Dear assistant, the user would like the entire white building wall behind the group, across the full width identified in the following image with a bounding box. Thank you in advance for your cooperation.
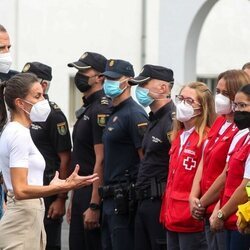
[0,0,250,116]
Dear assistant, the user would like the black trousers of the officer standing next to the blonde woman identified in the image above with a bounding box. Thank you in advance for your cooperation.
[135,199,167,250]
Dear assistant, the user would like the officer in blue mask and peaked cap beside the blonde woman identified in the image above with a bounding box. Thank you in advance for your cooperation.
[129,64,175,250]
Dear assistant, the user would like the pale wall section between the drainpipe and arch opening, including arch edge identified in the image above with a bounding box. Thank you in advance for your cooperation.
[159,0,217,95]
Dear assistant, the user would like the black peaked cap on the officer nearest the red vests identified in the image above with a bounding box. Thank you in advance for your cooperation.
[128,64,174,85]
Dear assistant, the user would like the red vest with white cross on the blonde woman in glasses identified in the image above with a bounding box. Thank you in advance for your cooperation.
[160,131,207,232]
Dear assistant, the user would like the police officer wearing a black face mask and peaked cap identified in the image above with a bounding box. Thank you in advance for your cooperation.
[68,52,111,250]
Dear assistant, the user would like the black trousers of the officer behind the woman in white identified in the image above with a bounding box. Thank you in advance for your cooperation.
[44,196,63,250]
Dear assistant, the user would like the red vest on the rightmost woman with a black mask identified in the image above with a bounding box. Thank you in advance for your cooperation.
[221,135,250,230]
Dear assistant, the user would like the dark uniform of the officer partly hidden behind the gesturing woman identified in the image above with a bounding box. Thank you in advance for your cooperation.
[30,95,71,249]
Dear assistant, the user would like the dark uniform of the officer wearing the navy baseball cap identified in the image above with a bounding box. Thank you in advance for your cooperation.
[101,97,148,250]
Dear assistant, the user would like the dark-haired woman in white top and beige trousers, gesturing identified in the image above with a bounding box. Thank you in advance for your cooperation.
[0,74,98,250]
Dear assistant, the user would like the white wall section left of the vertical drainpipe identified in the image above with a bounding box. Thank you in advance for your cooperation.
[0,0,141,115]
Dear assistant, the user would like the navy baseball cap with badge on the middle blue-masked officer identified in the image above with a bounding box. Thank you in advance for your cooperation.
[102,59,135,79]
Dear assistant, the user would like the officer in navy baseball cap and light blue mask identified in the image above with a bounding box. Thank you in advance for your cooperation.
[100,59,148,250]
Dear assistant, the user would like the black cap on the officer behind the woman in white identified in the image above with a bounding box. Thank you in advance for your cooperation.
[22,62,52,81]
